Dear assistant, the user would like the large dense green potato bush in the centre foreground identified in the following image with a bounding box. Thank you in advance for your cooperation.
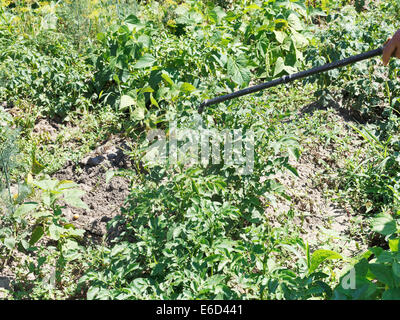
[80,165,337,299]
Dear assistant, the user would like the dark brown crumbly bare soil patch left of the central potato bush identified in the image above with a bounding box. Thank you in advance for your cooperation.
[53,136,130,239]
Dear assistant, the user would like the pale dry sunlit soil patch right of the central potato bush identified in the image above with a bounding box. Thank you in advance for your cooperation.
[266,104,368,257]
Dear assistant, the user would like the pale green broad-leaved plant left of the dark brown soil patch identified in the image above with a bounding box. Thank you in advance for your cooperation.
[0,176,87,299]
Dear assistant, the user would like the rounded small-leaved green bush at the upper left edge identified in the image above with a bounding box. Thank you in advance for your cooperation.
[0,7,91,116]
